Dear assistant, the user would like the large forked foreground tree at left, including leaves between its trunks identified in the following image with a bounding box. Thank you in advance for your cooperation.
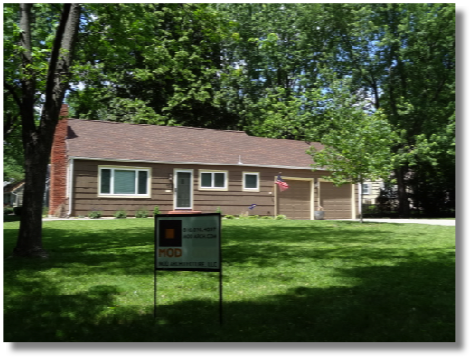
[3,4,80,257]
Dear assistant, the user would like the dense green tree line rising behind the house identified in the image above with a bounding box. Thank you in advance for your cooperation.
[3,3,456,256]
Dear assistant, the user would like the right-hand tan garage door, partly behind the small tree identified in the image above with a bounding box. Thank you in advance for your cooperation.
[319,182,352,219]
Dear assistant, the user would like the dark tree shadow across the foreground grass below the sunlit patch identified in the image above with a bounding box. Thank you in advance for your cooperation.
[4,255,455,342]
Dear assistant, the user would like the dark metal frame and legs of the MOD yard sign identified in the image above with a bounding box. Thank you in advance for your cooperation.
[154,213,223,324]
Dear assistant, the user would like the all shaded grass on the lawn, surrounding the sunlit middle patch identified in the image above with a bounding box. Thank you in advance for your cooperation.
[4,223,455,342]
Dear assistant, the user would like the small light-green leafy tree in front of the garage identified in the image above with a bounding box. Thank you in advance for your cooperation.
[308,78,396,222]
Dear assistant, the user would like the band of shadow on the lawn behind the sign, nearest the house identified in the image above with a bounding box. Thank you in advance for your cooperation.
[3,221,400,275]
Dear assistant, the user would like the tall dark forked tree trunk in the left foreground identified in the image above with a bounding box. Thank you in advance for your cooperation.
[13,4,80,257]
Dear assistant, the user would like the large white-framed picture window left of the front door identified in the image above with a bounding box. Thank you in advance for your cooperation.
[98,166,151,197]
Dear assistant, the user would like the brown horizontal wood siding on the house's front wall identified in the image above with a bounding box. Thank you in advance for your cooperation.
[72,160,352,218]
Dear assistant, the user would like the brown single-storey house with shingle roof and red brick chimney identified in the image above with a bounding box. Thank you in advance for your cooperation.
[49,106,358,219]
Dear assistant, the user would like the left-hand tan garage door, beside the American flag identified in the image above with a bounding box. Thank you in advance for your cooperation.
[277,177,311,220]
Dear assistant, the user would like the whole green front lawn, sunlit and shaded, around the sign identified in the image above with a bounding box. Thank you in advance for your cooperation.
[3,218,455,342]
